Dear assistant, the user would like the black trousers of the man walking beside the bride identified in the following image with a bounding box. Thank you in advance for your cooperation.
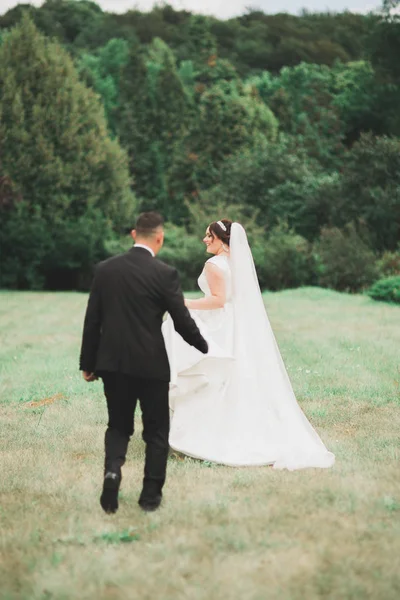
[101,372,169,496]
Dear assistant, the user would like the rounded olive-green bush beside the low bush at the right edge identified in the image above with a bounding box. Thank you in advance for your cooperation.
[314,224,378,292]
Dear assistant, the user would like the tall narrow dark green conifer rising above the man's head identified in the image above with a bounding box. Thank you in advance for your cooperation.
[118,38,190,218]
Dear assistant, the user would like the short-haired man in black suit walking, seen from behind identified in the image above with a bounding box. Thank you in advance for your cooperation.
[80,212,208,513]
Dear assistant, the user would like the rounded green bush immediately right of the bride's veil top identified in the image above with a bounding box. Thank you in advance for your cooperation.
[253,223,314,290]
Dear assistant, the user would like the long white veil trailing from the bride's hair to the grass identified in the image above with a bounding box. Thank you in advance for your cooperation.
[230,223,335,470]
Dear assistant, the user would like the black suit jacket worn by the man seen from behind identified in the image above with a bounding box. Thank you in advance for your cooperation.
[80,247,208,381]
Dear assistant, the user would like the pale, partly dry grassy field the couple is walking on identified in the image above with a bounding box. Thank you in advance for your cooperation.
[0,289,400,600]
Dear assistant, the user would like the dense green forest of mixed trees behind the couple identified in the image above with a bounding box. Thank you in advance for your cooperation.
[0,0,400,291]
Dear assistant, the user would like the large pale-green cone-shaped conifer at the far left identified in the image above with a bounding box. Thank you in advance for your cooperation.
[0,17,135,285]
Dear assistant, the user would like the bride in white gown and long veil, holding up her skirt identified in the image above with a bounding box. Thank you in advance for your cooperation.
[163,219,335,470]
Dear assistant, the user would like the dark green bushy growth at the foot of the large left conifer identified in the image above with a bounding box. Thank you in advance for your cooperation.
[0,202,113,290]
